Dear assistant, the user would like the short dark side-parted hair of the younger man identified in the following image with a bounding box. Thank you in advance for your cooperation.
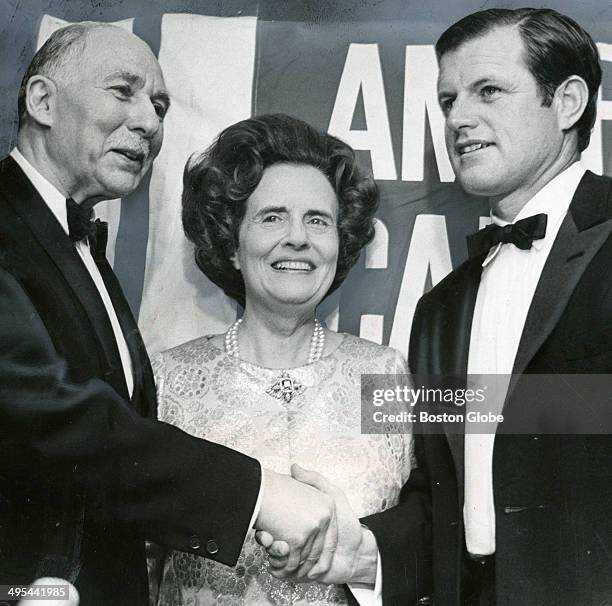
[436,8,601,151]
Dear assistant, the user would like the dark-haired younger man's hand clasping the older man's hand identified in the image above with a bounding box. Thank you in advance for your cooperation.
[257,465,378,585]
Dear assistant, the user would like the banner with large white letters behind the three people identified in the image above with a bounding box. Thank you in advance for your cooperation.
[0,0,612,360]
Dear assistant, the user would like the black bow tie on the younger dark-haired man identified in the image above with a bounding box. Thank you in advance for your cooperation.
[467,213,548,257]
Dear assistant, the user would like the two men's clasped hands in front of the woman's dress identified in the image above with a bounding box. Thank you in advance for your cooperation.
[254,465,378,585]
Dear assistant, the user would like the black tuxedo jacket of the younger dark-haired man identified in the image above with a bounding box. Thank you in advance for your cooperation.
[400,173,612,606]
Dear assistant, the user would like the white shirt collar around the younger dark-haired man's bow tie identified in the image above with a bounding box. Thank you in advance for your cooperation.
[482,161,586,267]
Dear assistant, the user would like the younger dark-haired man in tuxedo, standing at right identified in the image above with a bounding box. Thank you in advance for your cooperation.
[408,9,612,606]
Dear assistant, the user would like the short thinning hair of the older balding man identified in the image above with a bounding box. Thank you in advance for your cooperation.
[17,21,110,128]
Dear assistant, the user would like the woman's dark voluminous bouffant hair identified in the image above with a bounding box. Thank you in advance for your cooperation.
[183,114,378,306]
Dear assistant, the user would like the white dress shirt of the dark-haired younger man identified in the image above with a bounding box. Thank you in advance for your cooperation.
[463,162,585,555]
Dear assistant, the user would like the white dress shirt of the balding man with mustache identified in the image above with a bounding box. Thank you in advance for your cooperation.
[11,147,134,397]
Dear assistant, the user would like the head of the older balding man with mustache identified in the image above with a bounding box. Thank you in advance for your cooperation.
[18,22,169,203]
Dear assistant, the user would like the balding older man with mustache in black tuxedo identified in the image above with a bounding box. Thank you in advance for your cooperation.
[0,23,335,606]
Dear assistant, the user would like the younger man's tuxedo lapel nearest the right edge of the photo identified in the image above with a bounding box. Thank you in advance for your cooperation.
[506,172,612,384]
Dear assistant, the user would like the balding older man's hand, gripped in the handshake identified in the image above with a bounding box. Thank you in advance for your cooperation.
[254,469,338,576]
